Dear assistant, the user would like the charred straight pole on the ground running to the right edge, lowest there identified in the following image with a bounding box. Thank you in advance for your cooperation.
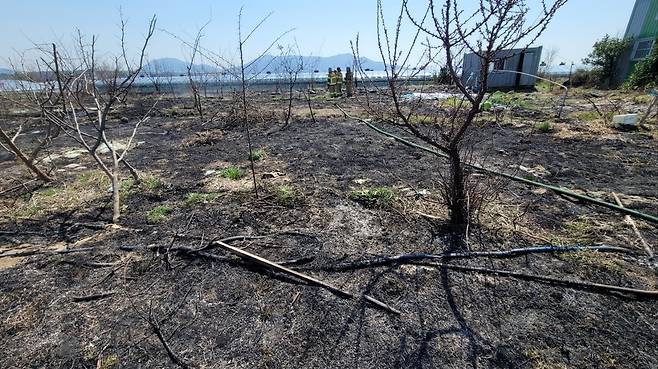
[423,262,658,299]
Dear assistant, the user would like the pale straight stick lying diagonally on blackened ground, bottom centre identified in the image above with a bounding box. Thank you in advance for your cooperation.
[213,241,401,315]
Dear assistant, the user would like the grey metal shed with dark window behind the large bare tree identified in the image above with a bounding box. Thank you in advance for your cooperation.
[461,46,542,91]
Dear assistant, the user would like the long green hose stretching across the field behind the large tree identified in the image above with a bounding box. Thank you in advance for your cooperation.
[336,104,658,225]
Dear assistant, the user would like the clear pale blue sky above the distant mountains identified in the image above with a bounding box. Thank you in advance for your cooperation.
[0,0,635,65]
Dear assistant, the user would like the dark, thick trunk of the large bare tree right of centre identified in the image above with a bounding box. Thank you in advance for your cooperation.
[448,147,469,240]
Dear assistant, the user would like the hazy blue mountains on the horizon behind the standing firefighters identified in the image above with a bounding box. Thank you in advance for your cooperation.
[143,54,384,76]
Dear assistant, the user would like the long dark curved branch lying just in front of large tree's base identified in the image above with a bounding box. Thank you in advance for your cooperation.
[323,246,633,271]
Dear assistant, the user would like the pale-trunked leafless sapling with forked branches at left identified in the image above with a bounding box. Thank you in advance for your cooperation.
[34,16,156,223]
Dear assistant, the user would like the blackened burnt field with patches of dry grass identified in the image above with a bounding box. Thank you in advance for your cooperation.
[0,92,658,368]
